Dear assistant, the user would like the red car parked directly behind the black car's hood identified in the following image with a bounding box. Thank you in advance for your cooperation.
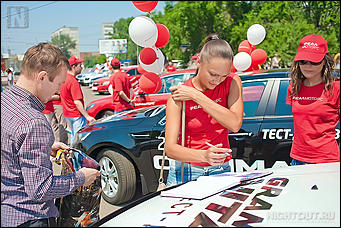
[86,69,195,119]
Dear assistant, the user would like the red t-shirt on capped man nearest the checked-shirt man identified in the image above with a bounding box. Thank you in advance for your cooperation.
[60,74,84,118]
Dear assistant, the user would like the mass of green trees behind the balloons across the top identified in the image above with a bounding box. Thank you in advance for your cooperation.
[107,1,340,66]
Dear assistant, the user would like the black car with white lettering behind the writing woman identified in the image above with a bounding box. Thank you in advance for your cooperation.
[74,72,340,204]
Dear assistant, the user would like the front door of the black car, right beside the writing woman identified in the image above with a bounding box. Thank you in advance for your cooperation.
[229,78,274,172]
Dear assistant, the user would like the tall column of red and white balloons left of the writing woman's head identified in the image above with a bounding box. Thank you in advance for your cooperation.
[129,1,170,94]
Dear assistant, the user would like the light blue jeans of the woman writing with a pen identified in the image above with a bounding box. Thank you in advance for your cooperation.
[166,160,231,187]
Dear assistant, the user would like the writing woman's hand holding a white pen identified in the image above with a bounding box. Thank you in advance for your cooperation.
[206,144,232,166]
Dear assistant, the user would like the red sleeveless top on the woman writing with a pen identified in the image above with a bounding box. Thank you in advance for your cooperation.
[178,75,234,166]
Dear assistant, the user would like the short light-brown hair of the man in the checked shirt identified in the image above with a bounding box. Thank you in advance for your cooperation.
[21,43,70,82]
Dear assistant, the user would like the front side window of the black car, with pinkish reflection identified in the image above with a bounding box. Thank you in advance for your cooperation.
[243,81,267,117]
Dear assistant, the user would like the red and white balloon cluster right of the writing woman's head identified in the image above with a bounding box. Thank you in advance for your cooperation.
[231,24,267,72]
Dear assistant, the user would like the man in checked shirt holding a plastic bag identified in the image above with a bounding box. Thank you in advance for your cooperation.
[1,43,100,227]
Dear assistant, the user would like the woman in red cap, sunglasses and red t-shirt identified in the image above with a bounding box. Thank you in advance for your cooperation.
[287,35,340,165]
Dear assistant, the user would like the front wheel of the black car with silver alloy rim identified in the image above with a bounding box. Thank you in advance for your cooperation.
[97,149,136,204]
